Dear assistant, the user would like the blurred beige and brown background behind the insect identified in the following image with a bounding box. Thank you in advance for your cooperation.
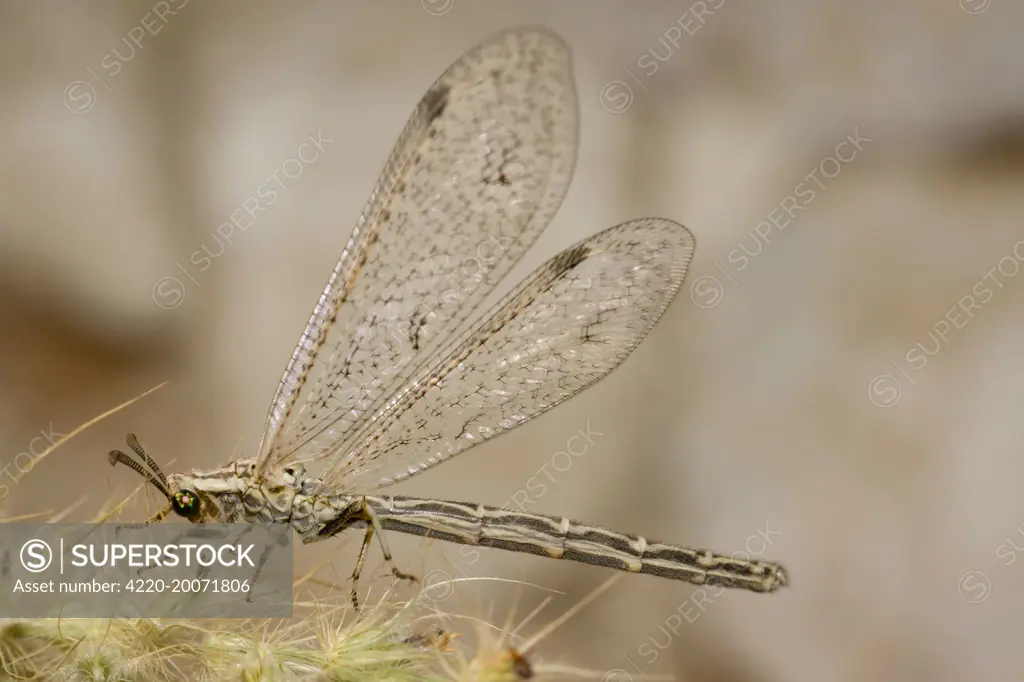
[0,0,1024,682]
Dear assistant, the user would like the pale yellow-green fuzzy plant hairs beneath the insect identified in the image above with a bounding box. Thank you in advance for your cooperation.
[0,384,613,682]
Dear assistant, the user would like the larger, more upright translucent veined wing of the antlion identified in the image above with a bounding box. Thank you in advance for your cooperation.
[258,29,578,472]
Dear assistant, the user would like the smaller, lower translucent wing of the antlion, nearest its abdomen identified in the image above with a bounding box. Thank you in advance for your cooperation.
[322,218,694,491]
